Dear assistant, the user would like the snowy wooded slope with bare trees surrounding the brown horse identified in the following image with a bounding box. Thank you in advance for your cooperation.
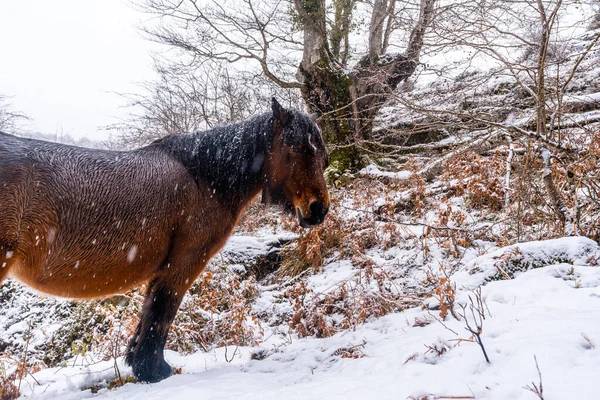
[0,0,600,400]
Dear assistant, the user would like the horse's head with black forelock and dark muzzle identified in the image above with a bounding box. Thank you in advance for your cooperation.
[263,98,329,228]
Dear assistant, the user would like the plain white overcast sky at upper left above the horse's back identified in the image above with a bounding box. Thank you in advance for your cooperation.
[0,0,156,139]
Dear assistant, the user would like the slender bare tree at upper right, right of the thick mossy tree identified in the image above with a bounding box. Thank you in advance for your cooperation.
[433,0,600,145]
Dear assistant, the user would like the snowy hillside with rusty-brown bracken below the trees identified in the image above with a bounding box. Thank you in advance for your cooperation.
[0,25,600,400]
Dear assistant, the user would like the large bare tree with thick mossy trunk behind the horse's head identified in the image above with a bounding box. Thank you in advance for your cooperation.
[140,0,435,170]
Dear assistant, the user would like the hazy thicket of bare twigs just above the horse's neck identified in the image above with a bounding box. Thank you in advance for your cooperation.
[107,60,300,147]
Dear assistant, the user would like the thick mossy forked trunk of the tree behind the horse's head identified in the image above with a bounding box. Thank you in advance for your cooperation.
[294,0,426,172]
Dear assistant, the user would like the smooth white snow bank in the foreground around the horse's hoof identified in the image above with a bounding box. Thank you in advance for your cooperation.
[11,237,600,400]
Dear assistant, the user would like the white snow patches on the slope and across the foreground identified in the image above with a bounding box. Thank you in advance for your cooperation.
[0,7,600,400]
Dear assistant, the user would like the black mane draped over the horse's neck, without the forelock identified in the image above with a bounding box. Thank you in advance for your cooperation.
[159,115,273,211]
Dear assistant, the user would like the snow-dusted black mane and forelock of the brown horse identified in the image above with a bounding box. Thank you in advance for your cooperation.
[152,104,327,211]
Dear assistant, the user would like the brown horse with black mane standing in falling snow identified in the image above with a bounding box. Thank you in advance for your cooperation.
[0,99,329,382]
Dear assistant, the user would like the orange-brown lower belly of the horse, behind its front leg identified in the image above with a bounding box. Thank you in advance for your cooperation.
[9,230,169,299]
